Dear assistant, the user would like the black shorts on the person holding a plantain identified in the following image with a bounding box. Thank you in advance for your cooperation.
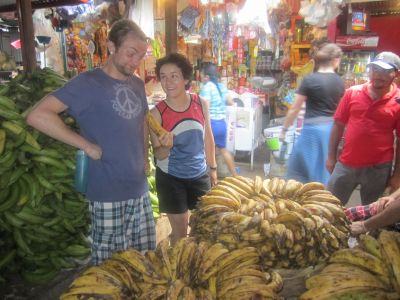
[156,168,211,214]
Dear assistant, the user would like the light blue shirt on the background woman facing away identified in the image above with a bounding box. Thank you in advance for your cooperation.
[200,81,228,120]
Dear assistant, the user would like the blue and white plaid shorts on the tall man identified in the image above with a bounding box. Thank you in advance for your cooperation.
[89,192,156,265]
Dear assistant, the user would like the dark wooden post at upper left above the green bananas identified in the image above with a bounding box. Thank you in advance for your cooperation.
[16,0,37,73]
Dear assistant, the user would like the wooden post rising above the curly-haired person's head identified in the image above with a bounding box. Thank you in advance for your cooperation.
[165,0,178,54]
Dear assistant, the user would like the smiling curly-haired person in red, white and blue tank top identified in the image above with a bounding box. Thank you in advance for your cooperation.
[150,53,217,245]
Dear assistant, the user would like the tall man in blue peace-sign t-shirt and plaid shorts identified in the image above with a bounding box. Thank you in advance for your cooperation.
[27,20,155,265]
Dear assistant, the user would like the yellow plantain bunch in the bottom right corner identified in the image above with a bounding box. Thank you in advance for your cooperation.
[299,231,400,300]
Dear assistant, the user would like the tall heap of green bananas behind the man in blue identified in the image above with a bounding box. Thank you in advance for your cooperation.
[0,70,90,283]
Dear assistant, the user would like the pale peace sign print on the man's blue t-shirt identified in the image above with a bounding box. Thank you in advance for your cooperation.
[111,84,142,119]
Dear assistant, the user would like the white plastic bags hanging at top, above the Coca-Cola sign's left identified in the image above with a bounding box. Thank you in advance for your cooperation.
[299,0,344,27]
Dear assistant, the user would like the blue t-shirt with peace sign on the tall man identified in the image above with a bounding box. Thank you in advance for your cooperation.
[53,69,148,202]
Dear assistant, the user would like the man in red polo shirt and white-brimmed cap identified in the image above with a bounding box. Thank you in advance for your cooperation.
[326,52,400,205]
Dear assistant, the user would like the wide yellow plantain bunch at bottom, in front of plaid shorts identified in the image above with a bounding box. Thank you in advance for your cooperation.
[60,238,283,300]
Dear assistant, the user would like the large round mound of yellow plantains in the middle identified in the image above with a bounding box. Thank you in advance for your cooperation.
[190,176,349,268]
